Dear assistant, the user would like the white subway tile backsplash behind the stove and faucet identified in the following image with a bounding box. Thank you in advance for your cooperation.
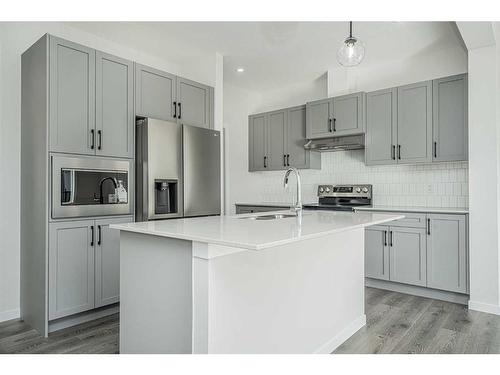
[261,150,469,207]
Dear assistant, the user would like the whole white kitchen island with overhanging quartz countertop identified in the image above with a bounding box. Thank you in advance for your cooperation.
[112,211,404,353]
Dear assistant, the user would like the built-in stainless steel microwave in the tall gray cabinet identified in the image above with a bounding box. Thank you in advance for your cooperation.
[51,155,133,219]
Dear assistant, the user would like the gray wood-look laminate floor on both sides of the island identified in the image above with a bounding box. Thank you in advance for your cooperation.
[0,288,500,354]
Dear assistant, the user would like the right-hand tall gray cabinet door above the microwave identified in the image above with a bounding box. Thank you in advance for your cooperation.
[96,51,134,158]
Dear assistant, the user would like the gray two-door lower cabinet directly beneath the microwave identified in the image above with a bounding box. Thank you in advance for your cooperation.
[49,216,133,320]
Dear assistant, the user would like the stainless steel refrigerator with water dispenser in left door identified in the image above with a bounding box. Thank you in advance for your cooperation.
[136,118,221,221]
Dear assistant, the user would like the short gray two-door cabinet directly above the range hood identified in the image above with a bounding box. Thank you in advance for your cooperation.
[306,92,365,139]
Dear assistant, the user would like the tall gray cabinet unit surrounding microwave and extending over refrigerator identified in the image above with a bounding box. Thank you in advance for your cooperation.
[21,35,213,335]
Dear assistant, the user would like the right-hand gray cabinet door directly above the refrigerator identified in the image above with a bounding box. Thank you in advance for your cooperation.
[177,77,211,128]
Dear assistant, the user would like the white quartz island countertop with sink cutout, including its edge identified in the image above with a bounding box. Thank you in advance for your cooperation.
[111,211,404,250]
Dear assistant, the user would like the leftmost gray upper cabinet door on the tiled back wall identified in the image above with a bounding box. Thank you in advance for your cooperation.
[248,114,268,171]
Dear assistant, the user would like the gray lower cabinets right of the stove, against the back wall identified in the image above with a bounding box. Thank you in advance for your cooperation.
[365,212,468,294]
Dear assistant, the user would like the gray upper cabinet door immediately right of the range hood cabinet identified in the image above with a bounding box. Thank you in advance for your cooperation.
[365,88,398,165]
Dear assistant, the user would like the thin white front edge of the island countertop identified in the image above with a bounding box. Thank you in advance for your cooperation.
[110,214,404,250]
